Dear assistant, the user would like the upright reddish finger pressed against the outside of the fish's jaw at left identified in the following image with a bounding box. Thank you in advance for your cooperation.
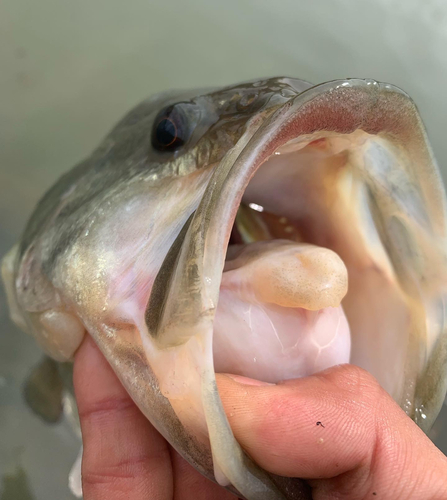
[73,335,173,500]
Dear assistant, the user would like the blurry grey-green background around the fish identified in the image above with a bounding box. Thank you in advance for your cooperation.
[0,0,447,500]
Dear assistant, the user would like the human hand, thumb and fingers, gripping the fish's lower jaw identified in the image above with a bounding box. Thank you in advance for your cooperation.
[74,336,447,500]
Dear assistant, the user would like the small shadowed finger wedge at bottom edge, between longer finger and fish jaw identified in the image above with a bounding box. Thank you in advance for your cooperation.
[171,448,237,500]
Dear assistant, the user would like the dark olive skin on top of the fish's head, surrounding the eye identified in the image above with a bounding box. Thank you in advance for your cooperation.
[20,78,308,274]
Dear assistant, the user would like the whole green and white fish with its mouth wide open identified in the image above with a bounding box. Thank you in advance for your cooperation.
[2,77,447,500]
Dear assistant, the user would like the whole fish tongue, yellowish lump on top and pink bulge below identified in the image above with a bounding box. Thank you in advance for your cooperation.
[213,240,351,382]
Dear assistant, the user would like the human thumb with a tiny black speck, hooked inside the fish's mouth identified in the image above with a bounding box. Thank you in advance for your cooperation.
[217,365,447,500]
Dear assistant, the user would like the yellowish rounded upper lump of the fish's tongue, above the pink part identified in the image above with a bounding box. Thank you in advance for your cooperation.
[221,240,348,311]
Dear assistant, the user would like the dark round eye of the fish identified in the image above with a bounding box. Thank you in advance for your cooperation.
[152,104,191,151]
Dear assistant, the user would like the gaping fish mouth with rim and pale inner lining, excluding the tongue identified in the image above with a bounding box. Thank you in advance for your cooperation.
[143,80,447,498]
